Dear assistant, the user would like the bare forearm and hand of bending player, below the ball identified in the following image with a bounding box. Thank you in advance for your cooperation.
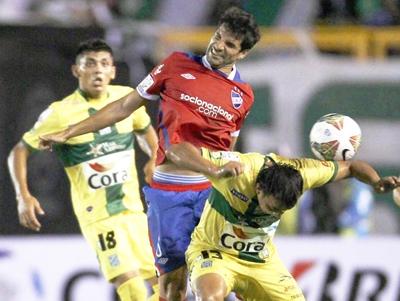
[334,160,400,193]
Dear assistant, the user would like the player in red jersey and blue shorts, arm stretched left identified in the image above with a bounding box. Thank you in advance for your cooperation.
[41,8,260,301]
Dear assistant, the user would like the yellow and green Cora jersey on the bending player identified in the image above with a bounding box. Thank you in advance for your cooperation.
[189,149,337,262]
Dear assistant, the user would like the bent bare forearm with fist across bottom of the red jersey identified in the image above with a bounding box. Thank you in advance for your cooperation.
[166,142,243,178]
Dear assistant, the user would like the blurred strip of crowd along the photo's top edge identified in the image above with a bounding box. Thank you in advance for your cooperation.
[0,0,400,27]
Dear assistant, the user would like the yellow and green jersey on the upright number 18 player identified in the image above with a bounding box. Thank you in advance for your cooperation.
[23,85,150,225]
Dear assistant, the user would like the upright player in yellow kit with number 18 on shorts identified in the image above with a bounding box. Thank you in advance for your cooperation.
[9,39,158,301]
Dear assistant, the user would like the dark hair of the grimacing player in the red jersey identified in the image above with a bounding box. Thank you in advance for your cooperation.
[218,6,260,50]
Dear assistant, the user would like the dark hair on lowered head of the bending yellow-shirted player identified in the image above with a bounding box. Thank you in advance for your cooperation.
[256,164,303,209]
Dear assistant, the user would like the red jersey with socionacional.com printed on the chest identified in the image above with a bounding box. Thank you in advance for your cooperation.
[137,52,254,164]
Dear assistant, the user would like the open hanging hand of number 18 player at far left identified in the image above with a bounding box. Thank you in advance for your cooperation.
[18,196,44,231]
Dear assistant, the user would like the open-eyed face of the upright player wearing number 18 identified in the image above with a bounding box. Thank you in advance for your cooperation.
[72,51,115,98]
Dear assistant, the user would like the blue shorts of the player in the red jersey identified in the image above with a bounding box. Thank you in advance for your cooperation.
[143,186,211,275]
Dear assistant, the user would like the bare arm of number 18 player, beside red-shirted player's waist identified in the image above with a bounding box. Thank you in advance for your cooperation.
[135,125,158,184]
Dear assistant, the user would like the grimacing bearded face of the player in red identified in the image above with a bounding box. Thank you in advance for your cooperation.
[206,25,248,73]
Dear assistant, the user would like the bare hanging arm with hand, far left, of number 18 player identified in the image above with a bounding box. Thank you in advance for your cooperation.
[8,142,44,231]
